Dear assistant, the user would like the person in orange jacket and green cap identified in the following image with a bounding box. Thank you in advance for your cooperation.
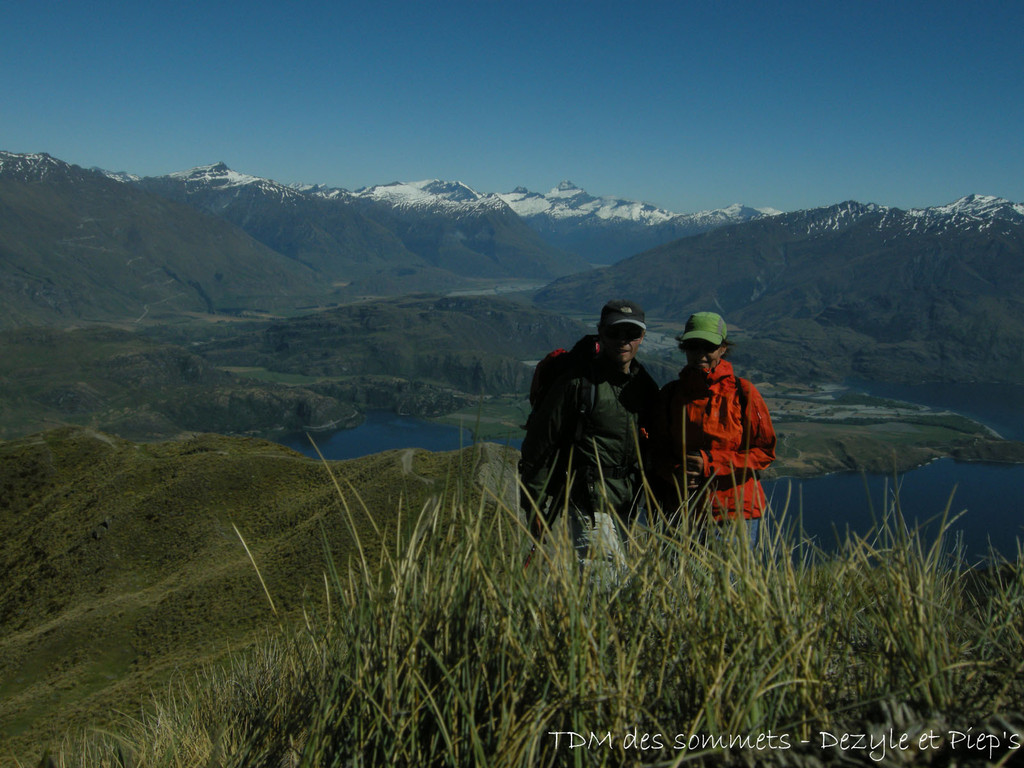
[653,312,775,546]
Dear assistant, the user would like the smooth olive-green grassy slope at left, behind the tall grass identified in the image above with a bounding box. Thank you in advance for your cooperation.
[0,429,512,759]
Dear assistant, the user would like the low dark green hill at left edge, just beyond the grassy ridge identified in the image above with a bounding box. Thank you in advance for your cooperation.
[0,327,361,440]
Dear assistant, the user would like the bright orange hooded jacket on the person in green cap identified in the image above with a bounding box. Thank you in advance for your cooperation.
[653,360,775,520]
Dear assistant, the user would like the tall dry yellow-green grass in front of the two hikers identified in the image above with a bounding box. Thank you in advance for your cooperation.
[51,462,1024,768]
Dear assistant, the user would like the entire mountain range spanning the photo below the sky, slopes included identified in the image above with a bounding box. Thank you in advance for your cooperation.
[6,153,1024,381]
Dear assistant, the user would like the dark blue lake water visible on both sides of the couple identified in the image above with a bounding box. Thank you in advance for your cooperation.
[284,382,1024,562]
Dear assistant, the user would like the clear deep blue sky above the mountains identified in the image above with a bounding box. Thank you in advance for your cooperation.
[0,0,1024,213]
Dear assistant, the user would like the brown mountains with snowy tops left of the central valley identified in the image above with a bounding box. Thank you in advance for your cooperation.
[0,152,588,328]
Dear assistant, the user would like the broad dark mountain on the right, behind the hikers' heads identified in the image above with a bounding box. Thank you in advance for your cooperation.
[537,196,1024,381]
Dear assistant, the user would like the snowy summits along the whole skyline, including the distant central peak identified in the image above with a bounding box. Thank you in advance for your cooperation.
[0,152,1024,263]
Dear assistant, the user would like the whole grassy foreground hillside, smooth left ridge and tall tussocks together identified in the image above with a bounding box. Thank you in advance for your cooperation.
[0,431,1024,768]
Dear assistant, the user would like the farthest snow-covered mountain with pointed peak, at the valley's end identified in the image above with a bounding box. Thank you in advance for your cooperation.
[498,181,779,264]
